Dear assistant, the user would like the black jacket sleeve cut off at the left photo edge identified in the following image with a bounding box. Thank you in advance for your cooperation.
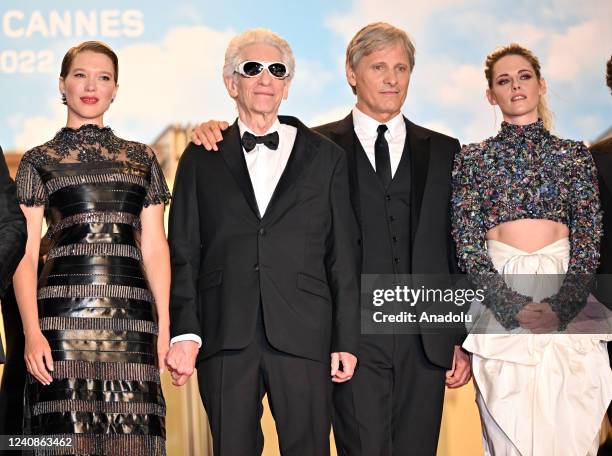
[0,148,27,362]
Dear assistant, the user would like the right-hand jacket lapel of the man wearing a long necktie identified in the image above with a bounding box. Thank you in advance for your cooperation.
[404,117,429,242]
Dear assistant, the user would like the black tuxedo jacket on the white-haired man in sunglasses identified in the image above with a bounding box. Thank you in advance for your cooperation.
[168,117,360,362]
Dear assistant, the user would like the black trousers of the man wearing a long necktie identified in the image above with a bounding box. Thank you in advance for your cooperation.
[333,334,446,456]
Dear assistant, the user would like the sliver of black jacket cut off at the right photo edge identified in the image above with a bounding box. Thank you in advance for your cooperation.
[591,138,612,306]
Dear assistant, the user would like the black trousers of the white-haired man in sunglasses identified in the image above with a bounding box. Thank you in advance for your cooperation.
[198,310,332,456]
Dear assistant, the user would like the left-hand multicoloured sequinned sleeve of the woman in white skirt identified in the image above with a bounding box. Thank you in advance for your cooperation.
[452,144,531,330]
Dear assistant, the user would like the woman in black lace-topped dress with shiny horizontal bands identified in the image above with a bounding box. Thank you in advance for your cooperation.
[14,41,170,456]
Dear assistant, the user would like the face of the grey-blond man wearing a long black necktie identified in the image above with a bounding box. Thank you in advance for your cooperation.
[346,44,410,122]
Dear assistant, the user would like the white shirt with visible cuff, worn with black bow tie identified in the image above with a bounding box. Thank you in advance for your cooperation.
[170,118,298,347]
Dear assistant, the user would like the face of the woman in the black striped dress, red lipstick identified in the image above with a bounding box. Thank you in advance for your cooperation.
[59,51,118,125]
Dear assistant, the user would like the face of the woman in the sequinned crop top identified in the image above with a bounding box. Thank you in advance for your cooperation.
[487,55,546,124]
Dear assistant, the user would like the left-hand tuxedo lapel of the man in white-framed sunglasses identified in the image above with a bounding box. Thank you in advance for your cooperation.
[219,121,261,218]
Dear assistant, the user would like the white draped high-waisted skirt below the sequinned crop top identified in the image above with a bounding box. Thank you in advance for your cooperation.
[463,238,612,456]
